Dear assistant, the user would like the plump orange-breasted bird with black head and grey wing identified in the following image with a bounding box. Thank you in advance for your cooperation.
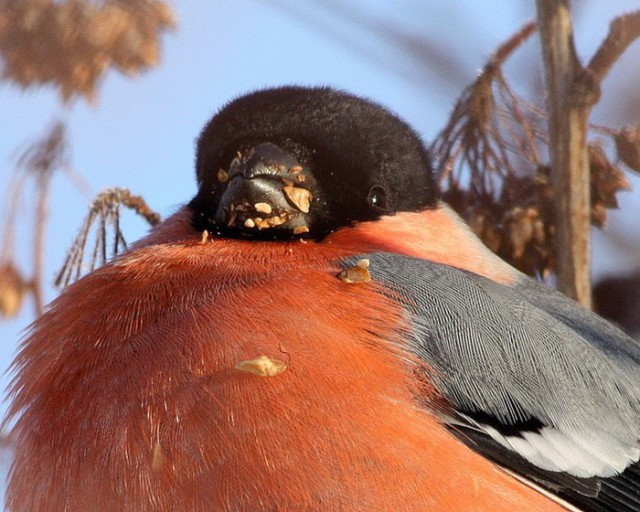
[5,86,640,512]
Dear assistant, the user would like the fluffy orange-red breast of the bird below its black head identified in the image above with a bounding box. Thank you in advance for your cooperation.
[9,222,560,512]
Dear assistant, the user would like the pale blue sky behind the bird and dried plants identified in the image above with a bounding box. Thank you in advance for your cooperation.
[0,0,640,496]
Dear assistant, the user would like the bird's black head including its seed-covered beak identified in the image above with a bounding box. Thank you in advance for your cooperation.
[190,87,437,239]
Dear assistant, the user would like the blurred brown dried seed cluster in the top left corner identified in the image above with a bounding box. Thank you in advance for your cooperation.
[0,0,175,101]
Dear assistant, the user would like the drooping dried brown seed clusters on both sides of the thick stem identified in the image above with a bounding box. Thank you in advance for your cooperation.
[432,18,640,277]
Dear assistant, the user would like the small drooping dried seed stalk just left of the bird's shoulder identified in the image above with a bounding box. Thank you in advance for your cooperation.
[55,188,160,288]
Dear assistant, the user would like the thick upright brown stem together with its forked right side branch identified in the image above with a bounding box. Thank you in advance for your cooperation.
[537,4,640,306]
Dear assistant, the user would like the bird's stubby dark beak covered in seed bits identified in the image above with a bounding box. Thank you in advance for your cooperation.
[215,143,315,238]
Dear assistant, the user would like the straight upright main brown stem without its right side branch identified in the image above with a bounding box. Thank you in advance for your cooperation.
[536,0,593,307]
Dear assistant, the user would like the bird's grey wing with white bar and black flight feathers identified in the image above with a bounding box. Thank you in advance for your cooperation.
[344,253,640,512]
